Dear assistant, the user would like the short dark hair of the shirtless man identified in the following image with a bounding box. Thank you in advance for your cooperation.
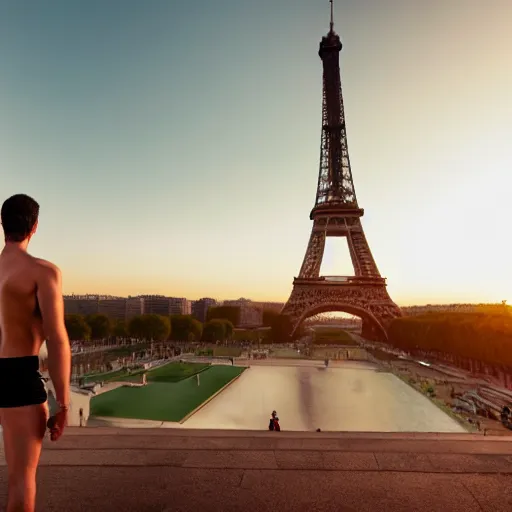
[1,194,39,242]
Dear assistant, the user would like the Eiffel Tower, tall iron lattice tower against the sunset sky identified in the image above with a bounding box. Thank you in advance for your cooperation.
[282,0,401,341]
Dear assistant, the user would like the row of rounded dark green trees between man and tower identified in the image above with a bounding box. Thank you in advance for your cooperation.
[65,314,233,342]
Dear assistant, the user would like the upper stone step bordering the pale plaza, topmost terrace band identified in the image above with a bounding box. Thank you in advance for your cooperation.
[40,429,512,455]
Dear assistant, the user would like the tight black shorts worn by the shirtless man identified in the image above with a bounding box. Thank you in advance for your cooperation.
[0,356,48,409]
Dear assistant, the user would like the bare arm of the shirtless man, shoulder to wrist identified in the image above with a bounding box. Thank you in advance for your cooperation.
[37,264,71,406]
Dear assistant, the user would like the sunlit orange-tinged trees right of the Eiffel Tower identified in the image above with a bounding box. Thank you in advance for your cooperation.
[388,313,512,367]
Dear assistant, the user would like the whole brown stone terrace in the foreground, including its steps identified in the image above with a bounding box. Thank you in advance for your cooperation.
[0,428,512,512]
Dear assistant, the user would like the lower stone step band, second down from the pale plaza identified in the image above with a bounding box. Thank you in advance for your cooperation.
[9,448,512,475]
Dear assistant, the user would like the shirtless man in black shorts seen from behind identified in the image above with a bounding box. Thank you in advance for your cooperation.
[0,194,71,512]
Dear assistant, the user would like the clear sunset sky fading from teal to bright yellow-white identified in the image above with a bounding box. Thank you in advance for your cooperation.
[0,0,512,305]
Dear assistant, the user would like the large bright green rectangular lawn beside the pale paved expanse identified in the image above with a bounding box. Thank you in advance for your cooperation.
[91,366,245,421]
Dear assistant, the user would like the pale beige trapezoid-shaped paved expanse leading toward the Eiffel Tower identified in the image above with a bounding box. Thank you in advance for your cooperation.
[184,361,466,432]
